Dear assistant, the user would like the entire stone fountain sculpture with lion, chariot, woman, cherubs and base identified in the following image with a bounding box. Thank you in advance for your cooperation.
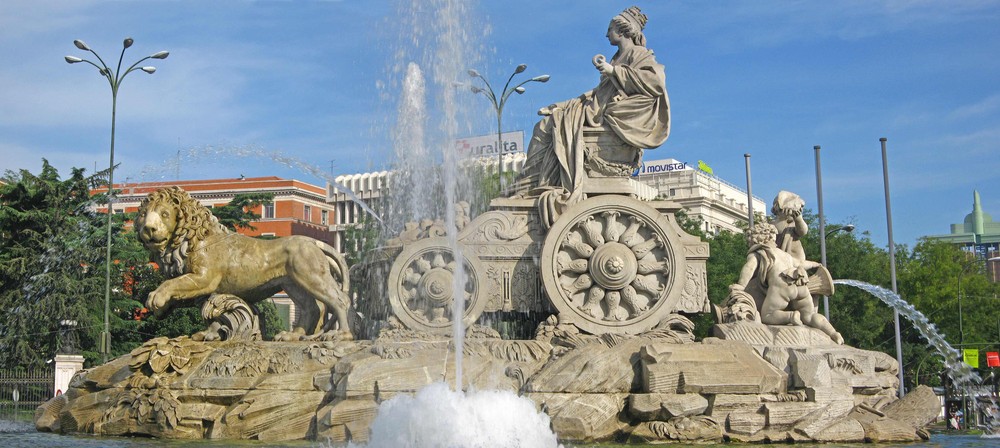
[35,7,938,443]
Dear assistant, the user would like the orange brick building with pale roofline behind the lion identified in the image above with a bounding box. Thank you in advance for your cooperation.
[99,176,335,244]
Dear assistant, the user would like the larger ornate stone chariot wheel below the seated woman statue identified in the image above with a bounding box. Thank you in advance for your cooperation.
[541,195,687,334]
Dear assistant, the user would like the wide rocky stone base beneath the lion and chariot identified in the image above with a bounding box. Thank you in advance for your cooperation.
[35,323,938,443]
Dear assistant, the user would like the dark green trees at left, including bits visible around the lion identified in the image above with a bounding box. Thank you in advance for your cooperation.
[0,164,282,367]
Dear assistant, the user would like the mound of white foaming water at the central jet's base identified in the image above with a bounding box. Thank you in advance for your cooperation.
[358,382,560,448]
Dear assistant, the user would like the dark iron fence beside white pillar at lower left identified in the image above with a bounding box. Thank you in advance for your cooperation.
[0,369,55,421]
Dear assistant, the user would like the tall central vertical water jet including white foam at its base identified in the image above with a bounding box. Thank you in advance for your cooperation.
[356,0,558,448]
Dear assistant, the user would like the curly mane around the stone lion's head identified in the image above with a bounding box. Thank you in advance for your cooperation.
[136,186,231,278]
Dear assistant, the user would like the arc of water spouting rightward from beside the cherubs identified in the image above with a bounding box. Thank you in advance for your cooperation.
[833,280,996,432]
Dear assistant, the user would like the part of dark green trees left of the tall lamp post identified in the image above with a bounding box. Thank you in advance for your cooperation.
[0,159,107,367]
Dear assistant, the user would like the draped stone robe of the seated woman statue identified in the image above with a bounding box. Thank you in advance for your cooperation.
[515,45,670,224]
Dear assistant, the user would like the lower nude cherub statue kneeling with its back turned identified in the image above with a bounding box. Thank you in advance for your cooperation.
[729,222,844,344]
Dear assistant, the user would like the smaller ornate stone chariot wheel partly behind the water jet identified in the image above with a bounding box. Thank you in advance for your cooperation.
[389,238,486,334]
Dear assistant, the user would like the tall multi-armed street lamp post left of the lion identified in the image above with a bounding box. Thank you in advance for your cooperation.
[66,37,170,362]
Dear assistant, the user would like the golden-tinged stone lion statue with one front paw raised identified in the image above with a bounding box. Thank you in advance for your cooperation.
[135,187,353,340]
